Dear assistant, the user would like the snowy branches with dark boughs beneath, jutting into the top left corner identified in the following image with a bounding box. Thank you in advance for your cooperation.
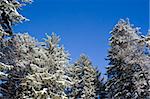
[0,0,31,39]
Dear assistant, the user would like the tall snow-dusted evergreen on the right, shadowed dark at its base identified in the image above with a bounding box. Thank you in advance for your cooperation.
[106,20,150,99]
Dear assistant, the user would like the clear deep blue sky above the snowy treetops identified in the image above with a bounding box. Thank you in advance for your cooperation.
[14,0,149,74]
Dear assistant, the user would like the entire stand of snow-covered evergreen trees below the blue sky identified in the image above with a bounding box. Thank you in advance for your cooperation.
[0,0,150,99]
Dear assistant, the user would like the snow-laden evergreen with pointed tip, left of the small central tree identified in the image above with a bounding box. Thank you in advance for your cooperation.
[16,33,71,99]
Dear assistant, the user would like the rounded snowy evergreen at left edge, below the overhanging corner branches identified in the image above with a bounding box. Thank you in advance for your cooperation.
[0,34,39,98]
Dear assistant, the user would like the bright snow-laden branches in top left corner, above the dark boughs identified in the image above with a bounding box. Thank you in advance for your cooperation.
[0,0,32,23]
